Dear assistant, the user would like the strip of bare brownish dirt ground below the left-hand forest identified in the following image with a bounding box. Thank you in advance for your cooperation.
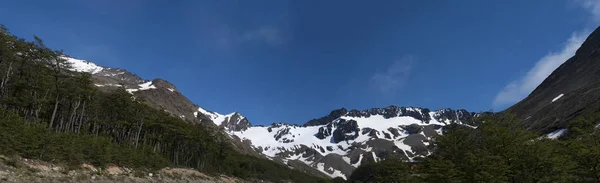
[0,155,266,183]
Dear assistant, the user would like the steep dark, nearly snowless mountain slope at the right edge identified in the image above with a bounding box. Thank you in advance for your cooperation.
[503,28,600,133]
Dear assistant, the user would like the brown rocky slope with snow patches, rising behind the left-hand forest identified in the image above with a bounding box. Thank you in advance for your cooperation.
[63,56,251,130]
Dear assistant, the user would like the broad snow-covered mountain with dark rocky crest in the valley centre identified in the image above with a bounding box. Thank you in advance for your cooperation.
[218,106,477,178]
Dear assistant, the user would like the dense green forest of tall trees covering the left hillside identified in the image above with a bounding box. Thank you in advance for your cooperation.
[0,26,328,182]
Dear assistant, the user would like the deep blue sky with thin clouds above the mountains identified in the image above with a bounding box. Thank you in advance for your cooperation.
[0,0,600,124]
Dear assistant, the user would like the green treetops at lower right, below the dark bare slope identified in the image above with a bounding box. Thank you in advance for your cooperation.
[348,112,600,183]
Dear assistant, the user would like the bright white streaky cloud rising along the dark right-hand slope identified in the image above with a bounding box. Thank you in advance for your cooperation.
[493,0,600,107]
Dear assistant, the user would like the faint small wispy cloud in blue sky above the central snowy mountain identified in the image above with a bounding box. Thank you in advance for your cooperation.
[371,56,414,94]
